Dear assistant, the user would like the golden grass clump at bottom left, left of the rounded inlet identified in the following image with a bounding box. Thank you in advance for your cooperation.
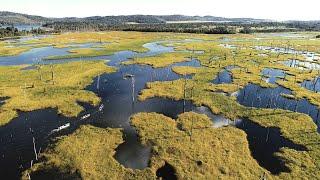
[22,126,155,179]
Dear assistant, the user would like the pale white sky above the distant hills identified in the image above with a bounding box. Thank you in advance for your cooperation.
[0,0,320,21]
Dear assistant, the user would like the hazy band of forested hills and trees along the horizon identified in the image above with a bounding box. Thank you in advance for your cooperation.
[0,11,320,38]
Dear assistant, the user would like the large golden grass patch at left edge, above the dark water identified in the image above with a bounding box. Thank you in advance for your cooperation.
[0,61,115,125]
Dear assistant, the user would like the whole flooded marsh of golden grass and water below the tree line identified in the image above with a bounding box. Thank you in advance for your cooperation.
[0,31,320,179]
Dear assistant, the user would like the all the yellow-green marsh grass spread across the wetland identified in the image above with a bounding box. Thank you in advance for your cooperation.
[0,32,320,179]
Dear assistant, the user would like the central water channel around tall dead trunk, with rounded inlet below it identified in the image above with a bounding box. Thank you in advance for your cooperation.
[88,60,199,169]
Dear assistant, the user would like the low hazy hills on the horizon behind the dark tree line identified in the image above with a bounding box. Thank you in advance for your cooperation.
[0,11,269,25]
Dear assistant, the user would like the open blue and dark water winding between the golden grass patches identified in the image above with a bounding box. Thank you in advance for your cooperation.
[0,39,319,179]
